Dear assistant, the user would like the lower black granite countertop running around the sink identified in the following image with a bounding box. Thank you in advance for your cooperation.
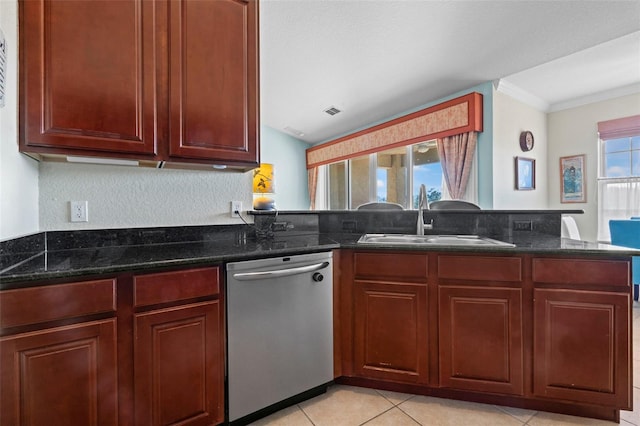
[0,233,640,289]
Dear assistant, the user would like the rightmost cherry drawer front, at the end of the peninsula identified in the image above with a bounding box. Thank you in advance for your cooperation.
[532,258,631,287]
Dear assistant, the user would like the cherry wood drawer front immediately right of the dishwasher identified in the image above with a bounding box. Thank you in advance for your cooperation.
[354,252,427,280]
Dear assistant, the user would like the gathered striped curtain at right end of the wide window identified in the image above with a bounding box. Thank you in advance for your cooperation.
[438,132,477,201]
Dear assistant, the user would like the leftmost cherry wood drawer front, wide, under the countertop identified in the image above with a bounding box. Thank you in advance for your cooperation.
[0,279,116,328]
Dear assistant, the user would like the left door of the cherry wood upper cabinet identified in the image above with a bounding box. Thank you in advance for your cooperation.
[20,0,157,156]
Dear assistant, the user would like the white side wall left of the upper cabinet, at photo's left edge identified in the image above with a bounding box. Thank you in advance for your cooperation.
[0,1,38,240]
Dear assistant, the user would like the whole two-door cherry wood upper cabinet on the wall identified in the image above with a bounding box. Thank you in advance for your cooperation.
[19,0,259,169]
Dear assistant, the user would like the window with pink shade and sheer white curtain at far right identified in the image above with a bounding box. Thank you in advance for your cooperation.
[598,116,640,241]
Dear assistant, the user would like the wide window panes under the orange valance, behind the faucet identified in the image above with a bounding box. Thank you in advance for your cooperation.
[318,140,443,210]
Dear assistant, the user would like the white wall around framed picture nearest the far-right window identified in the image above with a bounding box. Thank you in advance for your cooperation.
[547,94,640,241]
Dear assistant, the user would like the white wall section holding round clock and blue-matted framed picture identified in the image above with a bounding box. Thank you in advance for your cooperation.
[493,91,550,210]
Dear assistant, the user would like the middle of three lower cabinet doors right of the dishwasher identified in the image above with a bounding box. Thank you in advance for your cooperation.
[438,286,523,395]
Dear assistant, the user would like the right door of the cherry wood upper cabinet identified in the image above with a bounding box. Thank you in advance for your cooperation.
[169,0,259,165]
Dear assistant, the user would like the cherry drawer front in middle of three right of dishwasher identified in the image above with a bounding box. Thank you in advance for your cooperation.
[438,255,522,282]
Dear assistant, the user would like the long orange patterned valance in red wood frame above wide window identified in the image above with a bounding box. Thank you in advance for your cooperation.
[307,92,482,169]
